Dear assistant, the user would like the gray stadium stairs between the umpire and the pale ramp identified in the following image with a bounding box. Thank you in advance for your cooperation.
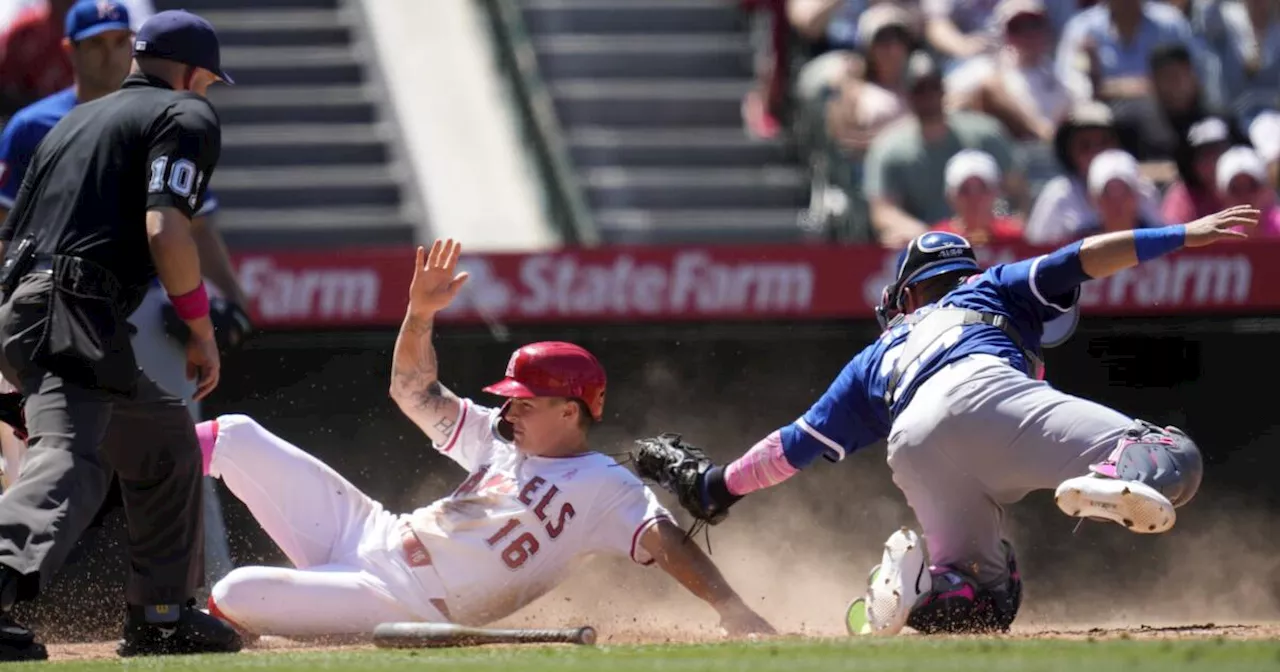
[155,0,416,248]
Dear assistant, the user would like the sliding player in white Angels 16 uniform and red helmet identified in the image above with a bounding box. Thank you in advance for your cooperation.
[197,241,773,636]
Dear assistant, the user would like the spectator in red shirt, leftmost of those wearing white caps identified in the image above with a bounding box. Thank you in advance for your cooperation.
[933,150,1023,244]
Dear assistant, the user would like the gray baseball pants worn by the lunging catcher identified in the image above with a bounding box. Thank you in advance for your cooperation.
[888,355,1133,586]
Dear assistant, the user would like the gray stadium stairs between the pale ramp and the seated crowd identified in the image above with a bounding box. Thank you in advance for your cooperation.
[520,0,809,243]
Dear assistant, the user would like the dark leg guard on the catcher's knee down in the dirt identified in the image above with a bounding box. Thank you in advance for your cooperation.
[906,541,1023,635]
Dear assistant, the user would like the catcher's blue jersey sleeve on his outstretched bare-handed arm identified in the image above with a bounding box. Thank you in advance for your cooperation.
[987,242,1089,321]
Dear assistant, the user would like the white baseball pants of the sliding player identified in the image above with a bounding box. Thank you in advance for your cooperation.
[209,415,445,636]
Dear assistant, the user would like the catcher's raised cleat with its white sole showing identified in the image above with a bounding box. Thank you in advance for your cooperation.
[1053,474,1178,534]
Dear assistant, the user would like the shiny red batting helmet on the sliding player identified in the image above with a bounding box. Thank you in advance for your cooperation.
[484,340,604,421]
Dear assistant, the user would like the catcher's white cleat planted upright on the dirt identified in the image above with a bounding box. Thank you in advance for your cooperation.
[845,527,933,635]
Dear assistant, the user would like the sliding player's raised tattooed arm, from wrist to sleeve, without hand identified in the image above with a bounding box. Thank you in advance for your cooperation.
[390,311,462,445]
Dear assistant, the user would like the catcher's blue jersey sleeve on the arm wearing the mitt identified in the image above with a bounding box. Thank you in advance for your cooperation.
[782,346,890,468]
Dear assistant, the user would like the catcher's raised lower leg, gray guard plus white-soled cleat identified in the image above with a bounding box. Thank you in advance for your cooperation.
[1055,420,1203,534]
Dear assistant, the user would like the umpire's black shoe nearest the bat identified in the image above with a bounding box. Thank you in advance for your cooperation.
[115,600,243,658]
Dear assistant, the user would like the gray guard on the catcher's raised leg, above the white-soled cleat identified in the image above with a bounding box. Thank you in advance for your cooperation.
[1115,420,1204,507]
